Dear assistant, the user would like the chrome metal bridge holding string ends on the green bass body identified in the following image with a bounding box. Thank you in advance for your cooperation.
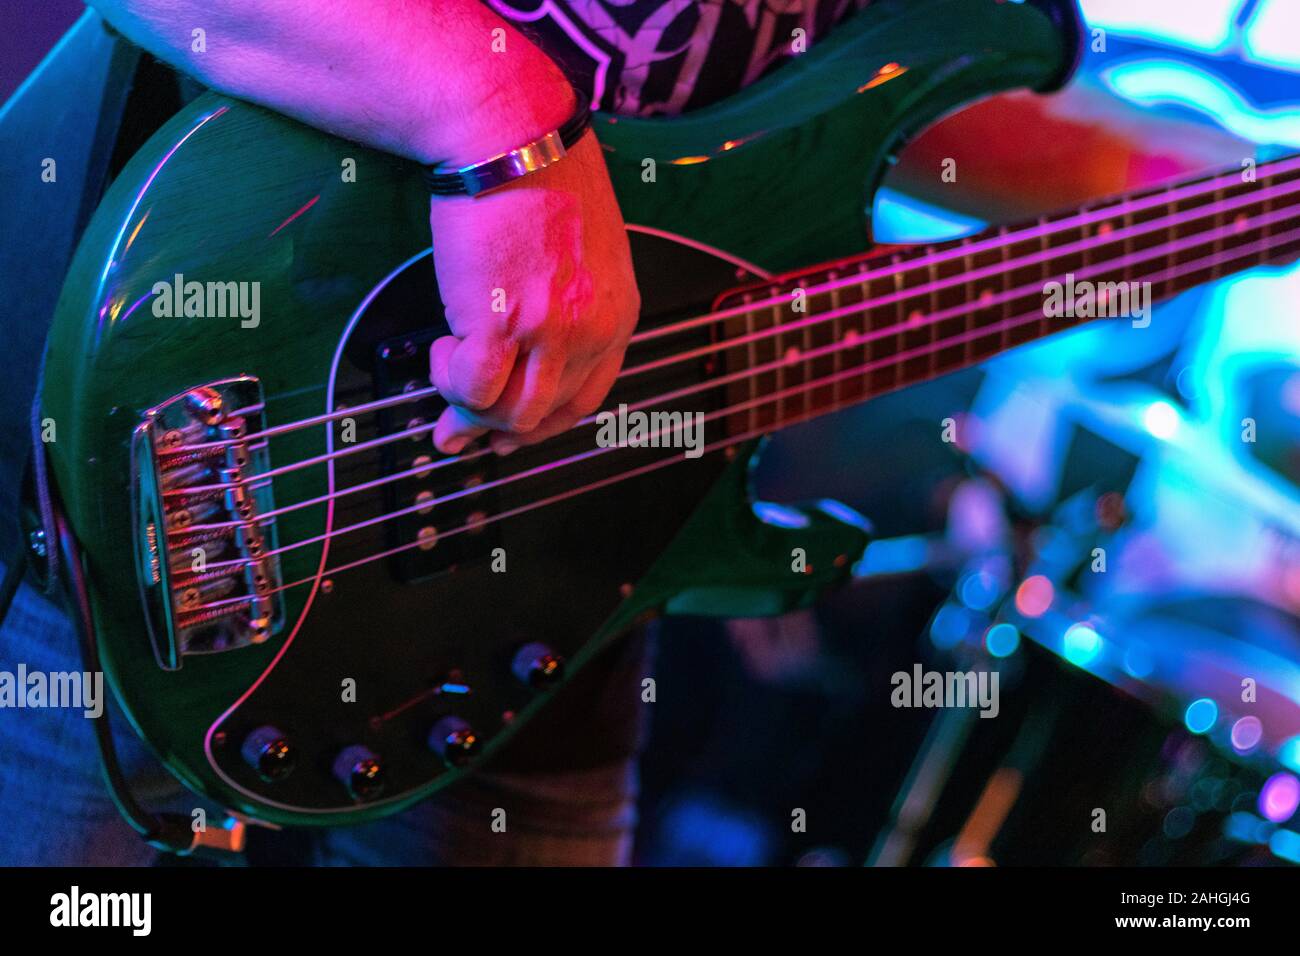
[131,376,283,670]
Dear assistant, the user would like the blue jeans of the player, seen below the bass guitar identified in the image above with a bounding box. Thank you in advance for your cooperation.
[0,567,645,866]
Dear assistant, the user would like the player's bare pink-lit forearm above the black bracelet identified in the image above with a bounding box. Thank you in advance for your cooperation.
[88,0,573,163]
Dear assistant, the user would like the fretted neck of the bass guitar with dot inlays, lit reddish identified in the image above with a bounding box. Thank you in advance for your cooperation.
[714,156,1300,436]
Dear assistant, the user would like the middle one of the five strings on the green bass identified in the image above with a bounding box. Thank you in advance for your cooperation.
[168,201,1290,535]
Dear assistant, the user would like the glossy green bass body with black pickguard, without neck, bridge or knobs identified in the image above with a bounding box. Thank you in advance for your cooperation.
[42,0,1078,825]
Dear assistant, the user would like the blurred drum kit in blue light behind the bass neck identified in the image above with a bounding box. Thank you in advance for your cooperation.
[858,261,1300,865]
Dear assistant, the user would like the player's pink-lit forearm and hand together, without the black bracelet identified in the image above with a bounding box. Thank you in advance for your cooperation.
[88,0,638,453]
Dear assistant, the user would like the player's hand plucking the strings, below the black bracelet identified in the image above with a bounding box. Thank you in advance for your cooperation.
[429,134,640,454]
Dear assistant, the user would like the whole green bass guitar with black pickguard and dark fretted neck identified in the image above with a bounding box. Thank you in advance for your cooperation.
[40,0,1300,825]
